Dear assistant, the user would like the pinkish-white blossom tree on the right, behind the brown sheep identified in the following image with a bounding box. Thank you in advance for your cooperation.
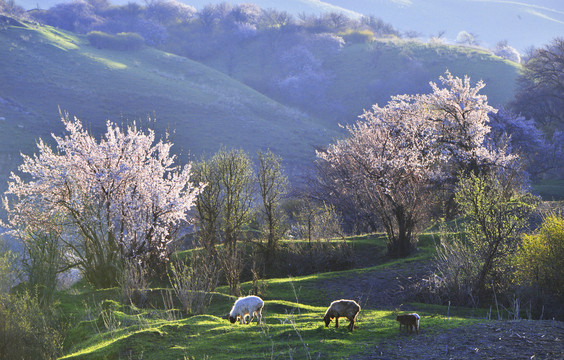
[318,71,514,256]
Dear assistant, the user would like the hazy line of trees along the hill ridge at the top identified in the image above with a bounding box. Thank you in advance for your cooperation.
[22,0,400,46]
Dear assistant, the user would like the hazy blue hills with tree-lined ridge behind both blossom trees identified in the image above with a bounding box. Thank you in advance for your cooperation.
[0,1,556,198]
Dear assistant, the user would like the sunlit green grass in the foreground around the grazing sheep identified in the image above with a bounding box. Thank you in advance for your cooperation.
[59,236,485,359]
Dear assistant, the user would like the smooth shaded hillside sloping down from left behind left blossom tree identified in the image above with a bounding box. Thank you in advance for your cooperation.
[0,19,333,187]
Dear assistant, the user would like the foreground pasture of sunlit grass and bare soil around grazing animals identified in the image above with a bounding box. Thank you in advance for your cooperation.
[53,234,564,360]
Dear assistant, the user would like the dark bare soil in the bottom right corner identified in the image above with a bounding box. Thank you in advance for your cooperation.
[350,320,564,360]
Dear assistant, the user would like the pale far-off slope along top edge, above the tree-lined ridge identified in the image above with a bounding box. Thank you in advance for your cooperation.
[16,0,564,52]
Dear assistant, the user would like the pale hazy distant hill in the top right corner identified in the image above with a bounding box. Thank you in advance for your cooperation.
[325,0,564,52]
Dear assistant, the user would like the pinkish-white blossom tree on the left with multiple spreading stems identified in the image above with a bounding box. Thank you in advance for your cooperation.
[4,114,202,286]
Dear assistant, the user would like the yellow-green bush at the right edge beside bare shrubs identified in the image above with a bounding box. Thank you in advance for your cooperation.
[515,213,564,296]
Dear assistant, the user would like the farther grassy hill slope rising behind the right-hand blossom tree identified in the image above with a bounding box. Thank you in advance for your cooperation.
[205,38,520,124]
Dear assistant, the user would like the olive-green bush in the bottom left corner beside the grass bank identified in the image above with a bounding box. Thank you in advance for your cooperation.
[0,292,63,359]
